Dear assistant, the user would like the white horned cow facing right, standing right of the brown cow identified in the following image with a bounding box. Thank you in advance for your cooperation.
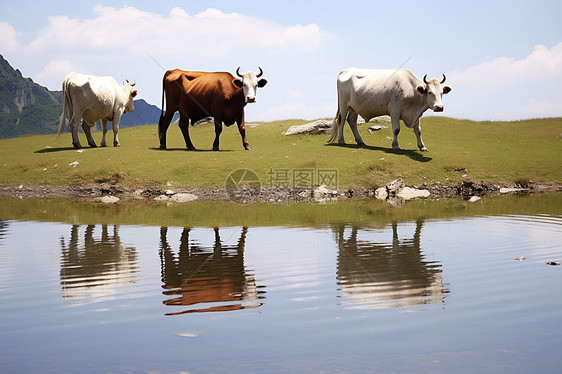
[329,68,451,152]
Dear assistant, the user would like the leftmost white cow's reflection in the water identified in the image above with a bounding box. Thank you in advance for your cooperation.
[60,225,137,298]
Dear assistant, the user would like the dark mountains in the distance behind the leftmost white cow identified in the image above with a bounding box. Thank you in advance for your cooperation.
[0,55,167,139]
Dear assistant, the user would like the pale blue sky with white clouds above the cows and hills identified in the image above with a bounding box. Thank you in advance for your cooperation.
[0,0,562,121]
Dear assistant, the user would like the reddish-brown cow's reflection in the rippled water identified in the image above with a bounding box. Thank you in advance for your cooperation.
[160,227,265,315]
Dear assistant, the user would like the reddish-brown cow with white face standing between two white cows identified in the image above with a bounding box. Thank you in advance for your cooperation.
[158,68,267,151]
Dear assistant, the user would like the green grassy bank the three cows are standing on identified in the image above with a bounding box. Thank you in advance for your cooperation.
[0,117,562,188]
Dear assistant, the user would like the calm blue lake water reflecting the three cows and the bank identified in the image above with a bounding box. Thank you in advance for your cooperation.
[0,194,562,373]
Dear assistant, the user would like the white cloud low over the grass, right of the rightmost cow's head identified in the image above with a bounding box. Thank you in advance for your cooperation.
[446,42,562,120]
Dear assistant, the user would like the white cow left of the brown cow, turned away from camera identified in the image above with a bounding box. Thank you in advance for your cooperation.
[58,73,137,148]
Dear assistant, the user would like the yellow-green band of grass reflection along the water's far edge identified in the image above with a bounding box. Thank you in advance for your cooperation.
[0,193,562,227]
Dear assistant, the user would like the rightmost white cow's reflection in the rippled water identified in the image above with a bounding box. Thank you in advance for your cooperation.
[334,220,448,308]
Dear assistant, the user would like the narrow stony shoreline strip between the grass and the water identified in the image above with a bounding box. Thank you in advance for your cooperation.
[0,180,562,204]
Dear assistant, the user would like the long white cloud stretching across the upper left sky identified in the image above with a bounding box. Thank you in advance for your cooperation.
[25,5,327,59]
